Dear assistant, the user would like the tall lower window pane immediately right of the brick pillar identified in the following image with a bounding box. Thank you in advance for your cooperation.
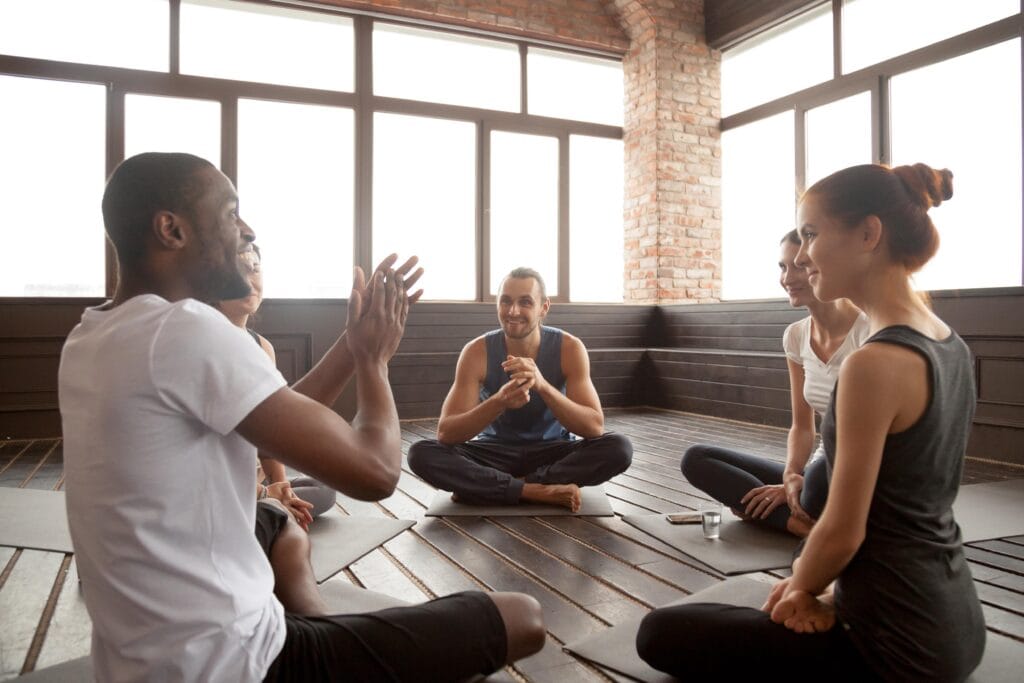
[722,112,797,299]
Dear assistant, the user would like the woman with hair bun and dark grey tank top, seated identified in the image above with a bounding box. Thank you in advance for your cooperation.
[637,164,985,681]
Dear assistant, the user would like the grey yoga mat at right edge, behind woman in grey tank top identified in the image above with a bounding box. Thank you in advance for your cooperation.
[953,479,1024,543]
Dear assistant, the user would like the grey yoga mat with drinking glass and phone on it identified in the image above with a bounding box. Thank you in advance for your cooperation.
[623,508,800,574]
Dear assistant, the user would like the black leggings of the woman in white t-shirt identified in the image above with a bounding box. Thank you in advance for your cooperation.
[681,444,828,531]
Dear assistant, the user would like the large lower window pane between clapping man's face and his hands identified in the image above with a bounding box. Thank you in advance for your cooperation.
[239,99,355,298]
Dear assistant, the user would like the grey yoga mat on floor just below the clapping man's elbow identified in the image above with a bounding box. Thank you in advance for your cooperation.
[309,508,416,584]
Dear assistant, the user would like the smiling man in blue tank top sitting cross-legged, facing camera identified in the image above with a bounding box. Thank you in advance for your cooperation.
[409,268,633,512]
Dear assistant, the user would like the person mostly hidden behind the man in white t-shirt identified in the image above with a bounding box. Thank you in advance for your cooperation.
[217,243,337,528]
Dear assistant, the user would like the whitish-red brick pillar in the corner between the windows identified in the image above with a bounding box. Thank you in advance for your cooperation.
[612,0,722,303]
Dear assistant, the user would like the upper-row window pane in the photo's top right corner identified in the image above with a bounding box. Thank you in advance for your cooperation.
[843,0,1021,73]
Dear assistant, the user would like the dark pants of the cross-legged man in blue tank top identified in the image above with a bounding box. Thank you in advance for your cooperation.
[409,432,633,505]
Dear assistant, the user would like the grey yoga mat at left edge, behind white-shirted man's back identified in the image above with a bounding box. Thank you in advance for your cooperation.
[0,487,74,553]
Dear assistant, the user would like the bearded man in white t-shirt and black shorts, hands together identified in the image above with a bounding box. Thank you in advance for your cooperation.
[59,153,545,681]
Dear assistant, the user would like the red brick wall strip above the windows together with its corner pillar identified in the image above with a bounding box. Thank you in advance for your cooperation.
[311,0,722,303]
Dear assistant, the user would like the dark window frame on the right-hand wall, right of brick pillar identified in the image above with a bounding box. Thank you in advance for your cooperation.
[721,0,1024,301]
